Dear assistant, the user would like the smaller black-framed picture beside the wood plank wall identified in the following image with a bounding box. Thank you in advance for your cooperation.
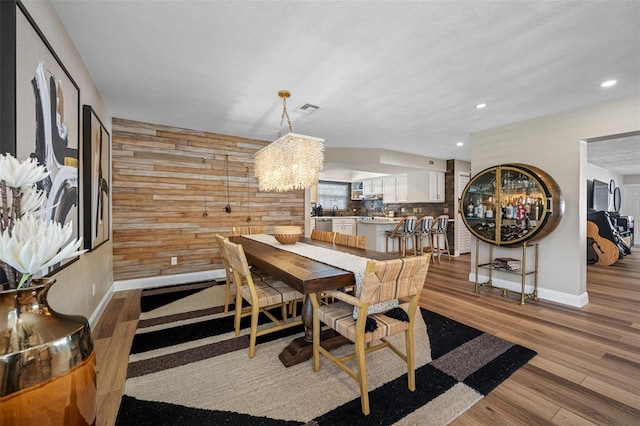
[82,105,111,251]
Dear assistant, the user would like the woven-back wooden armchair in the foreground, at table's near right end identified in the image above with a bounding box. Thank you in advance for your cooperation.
[311,253,431,415]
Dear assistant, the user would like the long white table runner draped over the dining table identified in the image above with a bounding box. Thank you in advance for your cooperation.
[242,234,399,318]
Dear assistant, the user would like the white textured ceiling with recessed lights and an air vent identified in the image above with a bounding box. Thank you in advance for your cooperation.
[53,0,640,175]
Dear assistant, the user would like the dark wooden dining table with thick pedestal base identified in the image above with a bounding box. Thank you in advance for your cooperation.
[229,236,400,367]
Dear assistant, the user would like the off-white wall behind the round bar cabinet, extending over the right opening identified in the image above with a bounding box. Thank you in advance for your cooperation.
[471,96,640,306]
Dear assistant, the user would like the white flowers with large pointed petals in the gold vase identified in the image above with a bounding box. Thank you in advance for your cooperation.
[0,154,86,289]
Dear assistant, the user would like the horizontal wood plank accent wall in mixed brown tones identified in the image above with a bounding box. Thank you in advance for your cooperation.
[112,118,304,281]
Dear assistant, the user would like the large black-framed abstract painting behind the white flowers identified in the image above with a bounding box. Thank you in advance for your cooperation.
[8,1,81,275]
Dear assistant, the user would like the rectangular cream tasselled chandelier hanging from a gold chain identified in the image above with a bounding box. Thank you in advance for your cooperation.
[255,90,324,192]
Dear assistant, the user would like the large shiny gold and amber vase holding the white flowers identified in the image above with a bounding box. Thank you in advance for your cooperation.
[0,279,96,426]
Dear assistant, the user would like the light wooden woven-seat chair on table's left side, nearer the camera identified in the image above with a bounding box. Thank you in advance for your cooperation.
[224,240,304,358]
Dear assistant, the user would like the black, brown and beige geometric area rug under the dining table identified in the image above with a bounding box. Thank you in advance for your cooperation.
[116,284,536,426]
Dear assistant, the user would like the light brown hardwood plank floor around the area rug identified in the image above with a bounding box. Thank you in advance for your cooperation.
[93,247,640,425]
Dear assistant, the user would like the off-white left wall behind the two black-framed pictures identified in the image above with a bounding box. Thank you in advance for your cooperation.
[17,0,113,325]
